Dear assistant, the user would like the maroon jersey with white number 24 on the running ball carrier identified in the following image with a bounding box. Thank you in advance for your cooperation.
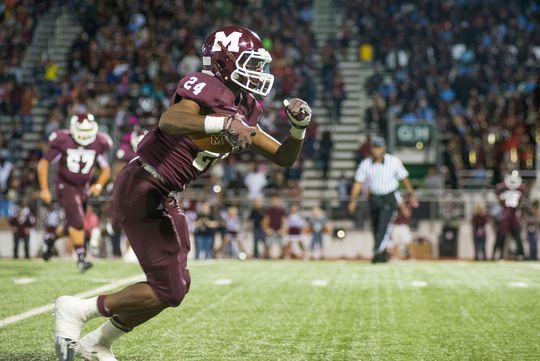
[137,73,262,190]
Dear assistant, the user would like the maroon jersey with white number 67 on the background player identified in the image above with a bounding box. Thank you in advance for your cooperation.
[44,129,112,186]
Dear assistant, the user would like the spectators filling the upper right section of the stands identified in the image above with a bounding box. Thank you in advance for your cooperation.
[340,0,540,188]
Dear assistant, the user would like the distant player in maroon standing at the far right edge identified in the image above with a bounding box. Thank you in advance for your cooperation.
[492,171,527,259]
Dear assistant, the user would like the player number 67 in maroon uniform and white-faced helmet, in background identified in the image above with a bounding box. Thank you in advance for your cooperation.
[37,114,112,272]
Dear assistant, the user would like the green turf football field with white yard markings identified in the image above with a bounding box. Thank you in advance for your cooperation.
[0,261,540,361]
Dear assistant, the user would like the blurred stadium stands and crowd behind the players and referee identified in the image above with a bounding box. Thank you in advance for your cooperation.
[0,0,540,259]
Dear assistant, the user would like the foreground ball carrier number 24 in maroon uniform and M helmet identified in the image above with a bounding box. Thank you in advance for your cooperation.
[55,26,311,360]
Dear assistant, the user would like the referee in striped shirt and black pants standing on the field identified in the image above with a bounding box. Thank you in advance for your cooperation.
[349,137,418,263]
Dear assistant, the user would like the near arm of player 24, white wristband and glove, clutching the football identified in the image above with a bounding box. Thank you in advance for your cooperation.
[158,98,256,151]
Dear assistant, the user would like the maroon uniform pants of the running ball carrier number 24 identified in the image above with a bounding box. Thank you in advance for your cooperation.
[113,161,191,307]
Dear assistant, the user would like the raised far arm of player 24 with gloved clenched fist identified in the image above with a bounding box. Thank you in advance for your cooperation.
[251,98,311,167]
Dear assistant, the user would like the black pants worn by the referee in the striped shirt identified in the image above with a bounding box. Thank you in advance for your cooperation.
[369,192,397,255]
